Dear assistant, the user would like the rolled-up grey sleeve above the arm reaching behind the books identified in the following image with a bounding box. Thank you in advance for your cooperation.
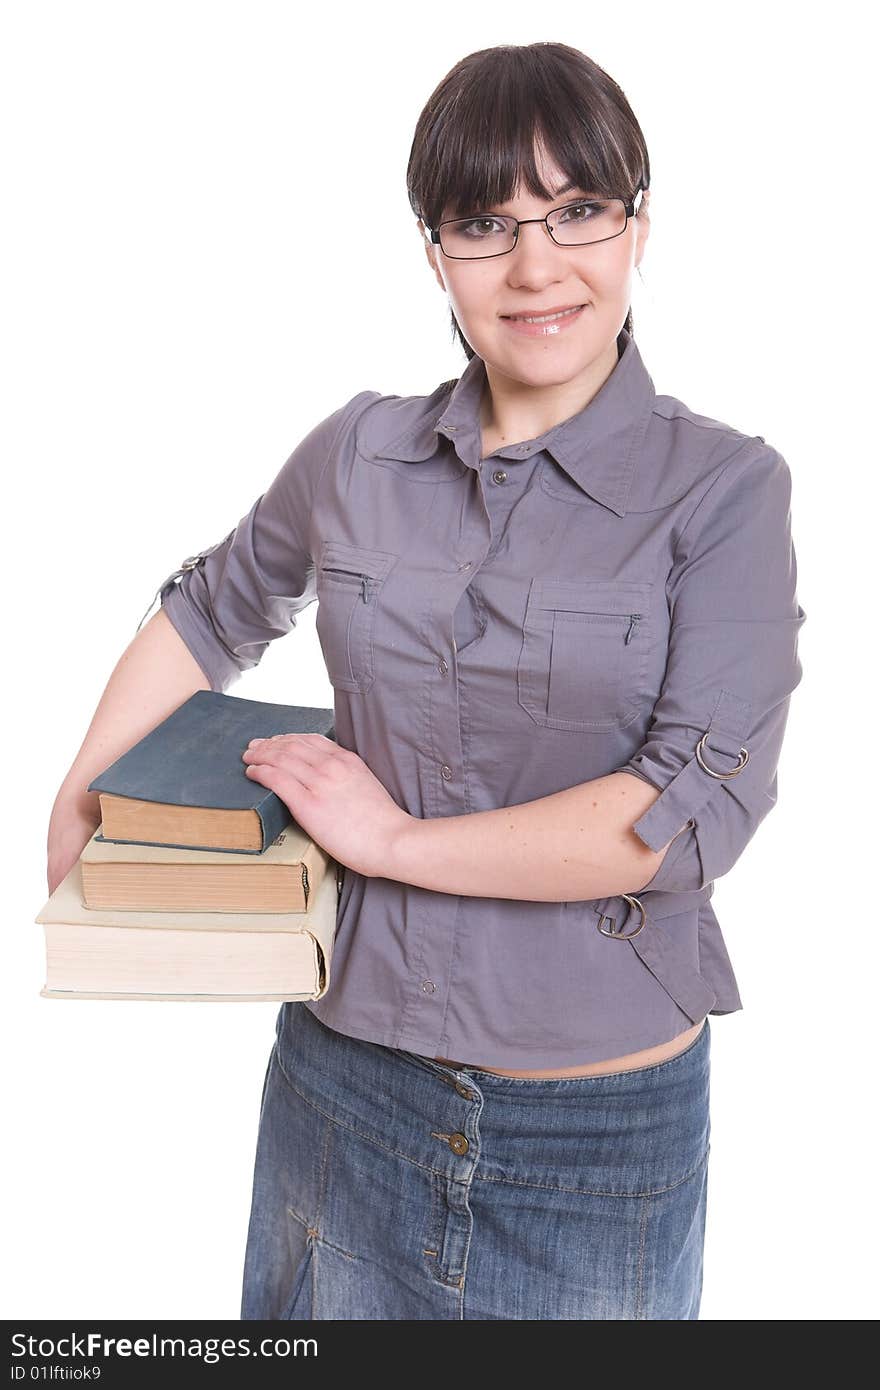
[139,391,377,691]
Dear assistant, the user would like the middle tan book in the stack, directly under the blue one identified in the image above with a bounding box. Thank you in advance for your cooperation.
[79,821,329,913]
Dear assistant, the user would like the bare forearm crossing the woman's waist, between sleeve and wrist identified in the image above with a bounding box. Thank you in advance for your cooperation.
[388,771,671,902]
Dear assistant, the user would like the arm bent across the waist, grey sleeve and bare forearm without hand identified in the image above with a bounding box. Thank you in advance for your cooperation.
[391,439,806,902]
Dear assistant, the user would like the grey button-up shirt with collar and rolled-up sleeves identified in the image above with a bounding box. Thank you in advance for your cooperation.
[142,329,806,1069]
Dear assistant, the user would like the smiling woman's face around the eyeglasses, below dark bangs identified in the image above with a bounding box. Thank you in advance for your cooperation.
[418,150,649,386]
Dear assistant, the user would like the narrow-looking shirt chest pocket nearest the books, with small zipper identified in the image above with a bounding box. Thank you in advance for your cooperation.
[316,541,398,694]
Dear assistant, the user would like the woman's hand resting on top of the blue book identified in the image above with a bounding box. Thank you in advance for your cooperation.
[242,734,413,878]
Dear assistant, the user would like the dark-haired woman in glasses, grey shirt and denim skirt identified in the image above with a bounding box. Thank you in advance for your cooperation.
[50,43,805,1319]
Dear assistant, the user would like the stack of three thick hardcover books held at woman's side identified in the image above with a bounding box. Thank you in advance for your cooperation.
[35,691,342,1001]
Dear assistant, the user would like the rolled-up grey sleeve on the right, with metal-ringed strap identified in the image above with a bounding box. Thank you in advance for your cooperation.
[619,441,806,892]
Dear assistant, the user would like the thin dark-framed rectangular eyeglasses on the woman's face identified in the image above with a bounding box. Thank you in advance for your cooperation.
[425,188,642,260]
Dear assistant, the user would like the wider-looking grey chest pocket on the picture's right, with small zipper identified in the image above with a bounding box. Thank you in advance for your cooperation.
[517,578,652,731]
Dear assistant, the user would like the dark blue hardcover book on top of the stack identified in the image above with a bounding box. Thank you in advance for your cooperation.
[89,691,335,855]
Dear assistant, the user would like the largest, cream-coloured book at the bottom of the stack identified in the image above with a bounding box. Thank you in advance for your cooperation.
[35,859,342,1002]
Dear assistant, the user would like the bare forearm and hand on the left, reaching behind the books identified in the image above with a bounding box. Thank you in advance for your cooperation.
[47,609,210,892]
